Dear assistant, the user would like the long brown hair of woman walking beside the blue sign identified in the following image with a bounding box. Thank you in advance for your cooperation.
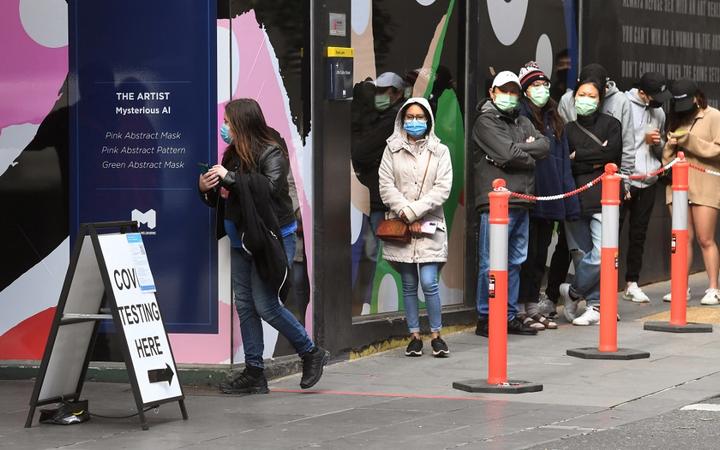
[222,98,282,172]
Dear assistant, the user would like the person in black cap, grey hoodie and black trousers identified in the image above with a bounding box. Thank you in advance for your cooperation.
[620,72,672,303]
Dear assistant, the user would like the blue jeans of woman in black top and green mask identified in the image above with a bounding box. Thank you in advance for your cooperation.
[565,214,602,306]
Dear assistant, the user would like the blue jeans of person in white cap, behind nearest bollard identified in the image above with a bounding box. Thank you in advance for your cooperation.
[477,208,530,320]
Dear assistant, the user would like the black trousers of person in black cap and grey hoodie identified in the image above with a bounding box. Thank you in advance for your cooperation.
[620,183,657,283]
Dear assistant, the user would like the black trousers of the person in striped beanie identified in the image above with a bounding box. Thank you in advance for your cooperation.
[518,217,555,303]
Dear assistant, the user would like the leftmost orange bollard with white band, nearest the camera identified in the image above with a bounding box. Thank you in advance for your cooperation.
[453,179,543,394]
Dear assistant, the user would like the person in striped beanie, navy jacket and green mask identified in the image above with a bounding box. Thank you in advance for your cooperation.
[519,62,580,330]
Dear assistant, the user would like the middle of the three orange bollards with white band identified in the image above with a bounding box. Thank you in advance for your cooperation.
[567,163,650,360]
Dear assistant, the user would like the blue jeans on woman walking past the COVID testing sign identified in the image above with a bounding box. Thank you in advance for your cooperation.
[230,233,314,368]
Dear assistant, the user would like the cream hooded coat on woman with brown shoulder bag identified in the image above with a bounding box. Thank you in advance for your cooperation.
[379,98,452,263]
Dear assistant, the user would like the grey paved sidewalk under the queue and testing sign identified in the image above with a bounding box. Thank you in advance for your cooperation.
[0,274,720,450]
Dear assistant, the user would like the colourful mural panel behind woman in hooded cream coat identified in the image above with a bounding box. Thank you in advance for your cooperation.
[350,0,466,315]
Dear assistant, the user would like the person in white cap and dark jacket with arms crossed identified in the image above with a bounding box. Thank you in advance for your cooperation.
[471,71,550,337]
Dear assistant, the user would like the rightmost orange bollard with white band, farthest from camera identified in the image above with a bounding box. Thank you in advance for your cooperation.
[644,152,712,333]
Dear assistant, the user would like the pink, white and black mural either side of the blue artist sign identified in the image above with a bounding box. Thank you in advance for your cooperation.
[0,0,312,364]
